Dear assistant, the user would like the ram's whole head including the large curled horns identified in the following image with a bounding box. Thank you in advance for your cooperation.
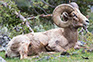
[53,2,89,28]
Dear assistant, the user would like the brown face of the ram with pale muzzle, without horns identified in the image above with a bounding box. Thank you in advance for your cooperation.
[71,8,89,28]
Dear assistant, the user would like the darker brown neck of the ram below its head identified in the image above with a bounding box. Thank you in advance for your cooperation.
[62,27,78,47]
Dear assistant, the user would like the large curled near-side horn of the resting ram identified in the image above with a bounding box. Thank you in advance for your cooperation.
[53,4,74,28]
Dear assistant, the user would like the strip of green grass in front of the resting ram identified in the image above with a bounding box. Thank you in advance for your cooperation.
[0,50,93,62]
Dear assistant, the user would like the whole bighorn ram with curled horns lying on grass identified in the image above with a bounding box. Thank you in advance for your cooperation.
[6,2,89,59]
